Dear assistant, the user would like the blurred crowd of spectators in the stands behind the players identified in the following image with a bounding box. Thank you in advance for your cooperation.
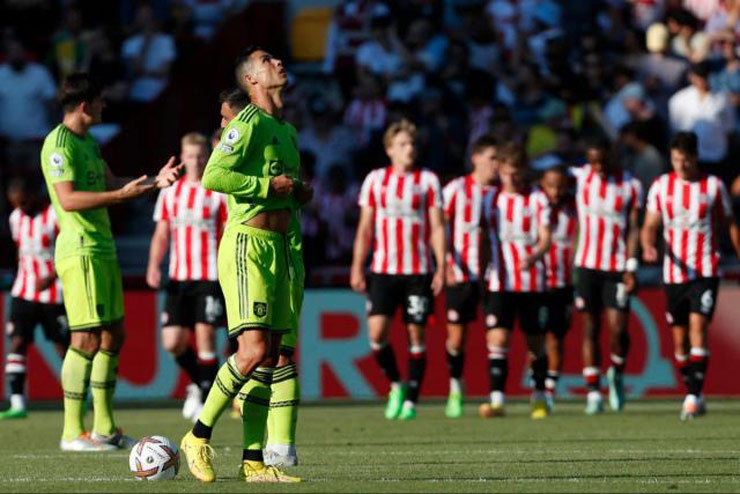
[0,0,740,282]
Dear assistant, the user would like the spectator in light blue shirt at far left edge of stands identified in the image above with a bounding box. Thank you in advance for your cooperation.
[0,39,56,171]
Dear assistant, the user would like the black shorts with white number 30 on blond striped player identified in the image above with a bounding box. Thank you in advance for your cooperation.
[367,274,434,325]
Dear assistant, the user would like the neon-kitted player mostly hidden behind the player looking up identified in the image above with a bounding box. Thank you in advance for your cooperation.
[220,88,306,466]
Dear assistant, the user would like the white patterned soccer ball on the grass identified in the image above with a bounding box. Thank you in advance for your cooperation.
[128,436,180,480]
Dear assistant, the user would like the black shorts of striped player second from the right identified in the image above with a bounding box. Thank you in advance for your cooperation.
[574,268,630,312]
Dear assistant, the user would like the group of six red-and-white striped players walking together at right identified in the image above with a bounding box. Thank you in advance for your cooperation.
[351,120,740,420]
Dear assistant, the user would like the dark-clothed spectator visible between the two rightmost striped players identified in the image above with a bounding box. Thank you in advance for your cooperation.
[620,122,666,190]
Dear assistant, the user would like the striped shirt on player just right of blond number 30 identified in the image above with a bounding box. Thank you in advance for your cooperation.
[442,175,491,283]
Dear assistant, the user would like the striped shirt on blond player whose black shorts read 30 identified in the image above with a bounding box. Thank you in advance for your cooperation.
[358,167,442,274]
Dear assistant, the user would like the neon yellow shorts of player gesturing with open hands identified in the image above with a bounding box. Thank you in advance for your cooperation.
[56,256,123,331]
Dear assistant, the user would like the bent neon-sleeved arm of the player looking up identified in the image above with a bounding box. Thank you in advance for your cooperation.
[202,120,295,199]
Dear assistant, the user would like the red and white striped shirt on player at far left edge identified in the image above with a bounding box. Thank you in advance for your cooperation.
[10,205,62,304]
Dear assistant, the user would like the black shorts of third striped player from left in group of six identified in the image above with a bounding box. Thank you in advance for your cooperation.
[485,292,545,334]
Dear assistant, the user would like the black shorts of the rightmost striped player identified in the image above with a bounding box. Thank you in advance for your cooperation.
[664,278,719,326]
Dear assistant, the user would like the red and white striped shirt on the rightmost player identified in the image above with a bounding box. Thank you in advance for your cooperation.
[647,173,732,283]
